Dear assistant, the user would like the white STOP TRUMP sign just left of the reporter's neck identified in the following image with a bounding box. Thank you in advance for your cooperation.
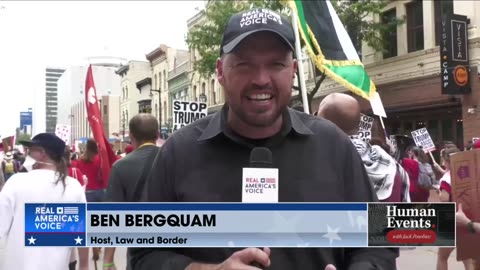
[173,100,208,130]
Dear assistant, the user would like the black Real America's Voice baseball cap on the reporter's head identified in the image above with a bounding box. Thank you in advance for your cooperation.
[220,8,295,55]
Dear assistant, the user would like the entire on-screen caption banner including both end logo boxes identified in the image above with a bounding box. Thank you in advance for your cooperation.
[25,203,455,247]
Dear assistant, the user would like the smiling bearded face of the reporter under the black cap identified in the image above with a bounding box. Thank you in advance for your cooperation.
[217,32,297,127]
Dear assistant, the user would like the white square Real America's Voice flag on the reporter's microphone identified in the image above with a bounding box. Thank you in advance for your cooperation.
[242,168,278,203]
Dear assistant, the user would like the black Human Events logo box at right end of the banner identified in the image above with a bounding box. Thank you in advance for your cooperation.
[369,203,455,246]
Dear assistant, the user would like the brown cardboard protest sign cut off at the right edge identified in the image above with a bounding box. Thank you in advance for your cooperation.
[450,149,480,261]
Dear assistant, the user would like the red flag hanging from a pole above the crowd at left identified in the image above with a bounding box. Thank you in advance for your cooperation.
[85,65,116,187]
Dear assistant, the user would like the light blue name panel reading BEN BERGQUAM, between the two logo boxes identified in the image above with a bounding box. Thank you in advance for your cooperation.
[87,203,367,247]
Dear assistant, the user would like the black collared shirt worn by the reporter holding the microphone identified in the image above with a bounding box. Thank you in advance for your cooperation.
[130,106,398,270]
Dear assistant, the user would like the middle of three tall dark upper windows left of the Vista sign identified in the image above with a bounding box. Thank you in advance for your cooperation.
[407,0,423,52]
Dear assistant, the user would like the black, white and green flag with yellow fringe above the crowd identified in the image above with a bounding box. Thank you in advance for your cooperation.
[286,0,375,100]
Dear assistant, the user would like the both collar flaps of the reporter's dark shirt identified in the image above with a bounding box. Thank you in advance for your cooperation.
[198,104,313,141]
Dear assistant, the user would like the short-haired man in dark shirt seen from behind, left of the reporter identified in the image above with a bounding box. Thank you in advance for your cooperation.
[103,114,159,270]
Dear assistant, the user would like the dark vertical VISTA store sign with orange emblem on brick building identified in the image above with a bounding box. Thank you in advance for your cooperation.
[440,14,472,95]
